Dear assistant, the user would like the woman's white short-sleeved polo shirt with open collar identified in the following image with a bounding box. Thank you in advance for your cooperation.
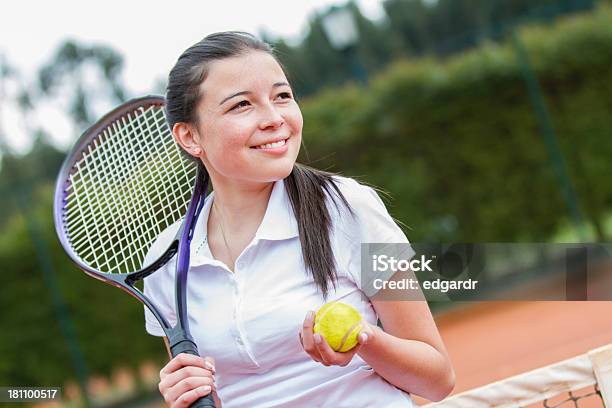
[144,177,415,408]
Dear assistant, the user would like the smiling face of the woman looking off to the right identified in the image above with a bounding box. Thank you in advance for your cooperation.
[187,51,302,184]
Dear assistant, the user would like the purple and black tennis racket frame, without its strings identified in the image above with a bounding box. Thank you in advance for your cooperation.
[53,95,215,408]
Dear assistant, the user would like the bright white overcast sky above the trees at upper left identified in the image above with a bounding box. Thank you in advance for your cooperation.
[0,0,384,152]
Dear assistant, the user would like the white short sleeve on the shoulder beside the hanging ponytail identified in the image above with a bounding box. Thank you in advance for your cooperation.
[340,178,415,297]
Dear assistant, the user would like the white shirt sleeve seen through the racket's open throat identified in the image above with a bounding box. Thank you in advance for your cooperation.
[143,222,180,336]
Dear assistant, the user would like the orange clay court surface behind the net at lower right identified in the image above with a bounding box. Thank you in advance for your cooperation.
[413,301,612,405]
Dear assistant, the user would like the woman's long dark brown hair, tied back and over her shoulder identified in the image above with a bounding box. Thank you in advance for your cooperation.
[166,31,353,299]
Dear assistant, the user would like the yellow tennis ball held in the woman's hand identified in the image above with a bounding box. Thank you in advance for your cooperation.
[314,302,362,352]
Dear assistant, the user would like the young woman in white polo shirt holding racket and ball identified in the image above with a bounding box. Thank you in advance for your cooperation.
[145,32,454,408]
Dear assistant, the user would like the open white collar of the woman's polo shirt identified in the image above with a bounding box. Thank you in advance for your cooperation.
[191,180,299,265]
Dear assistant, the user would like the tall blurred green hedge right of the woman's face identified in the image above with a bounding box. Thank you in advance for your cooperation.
[302,3,612,241]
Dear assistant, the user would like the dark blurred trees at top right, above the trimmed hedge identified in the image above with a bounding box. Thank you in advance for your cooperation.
[274,0,597,96]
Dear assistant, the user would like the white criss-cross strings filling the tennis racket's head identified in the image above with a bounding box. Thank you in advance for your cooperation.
[63,106,196,273]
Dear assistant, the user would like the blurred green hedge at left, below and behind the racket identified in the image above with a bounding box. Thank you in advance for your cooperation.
[0,185,165,386]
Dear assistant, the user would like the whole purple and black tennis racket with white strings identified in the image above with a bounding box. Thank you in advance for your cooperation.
[54,96,215,408]
